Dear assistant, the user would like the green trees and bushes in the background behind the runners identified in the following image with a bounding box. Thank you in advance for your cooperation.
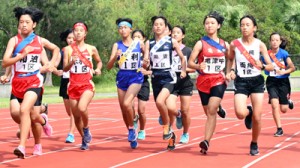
[0,0,300,85]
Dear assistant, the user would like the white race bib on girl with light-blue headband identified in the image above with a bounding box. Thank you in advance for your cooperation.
[119,52,140,70]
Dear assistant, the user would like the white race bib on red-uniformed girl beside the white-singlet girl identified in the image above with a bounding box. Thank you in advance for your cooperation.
[203,56,225,74]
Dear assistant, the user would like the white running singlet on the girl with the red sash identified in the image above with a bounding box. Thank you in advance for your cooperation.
[234,38,261,77]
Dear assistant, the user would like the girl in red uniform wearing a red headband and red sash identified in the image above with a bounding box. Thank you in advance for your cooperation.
[64,22,102,150]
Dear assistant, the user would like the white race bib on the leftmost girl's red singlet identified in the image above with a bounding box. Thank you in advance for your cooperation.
[16,54,41,72]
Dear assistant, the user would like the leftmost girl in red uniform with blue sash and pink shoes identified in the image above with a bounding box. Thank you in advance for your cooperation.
[2,7,59,158]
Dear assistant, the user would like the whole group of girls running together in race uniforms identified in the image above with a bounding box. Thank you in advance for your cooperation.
[1,7,295,158]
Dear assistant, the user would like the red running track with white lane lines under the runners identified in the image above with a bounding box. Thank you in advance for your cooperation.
[0,92,300,168]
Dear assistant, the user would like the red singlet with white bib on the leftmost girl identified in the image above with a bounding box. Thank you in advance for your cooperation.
[13,34,43,73]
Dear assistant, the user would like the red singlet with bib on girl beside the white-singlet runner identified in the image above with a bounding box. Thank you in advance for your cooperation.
[198,39,226,74]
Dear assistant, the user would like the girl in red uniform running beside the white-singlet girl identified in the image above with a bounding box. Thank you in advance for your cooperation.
[188,11,229,154]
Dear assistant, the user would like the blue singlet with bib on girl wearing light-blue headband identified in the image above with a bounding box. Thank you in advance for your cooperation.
[117,40,142,70]
